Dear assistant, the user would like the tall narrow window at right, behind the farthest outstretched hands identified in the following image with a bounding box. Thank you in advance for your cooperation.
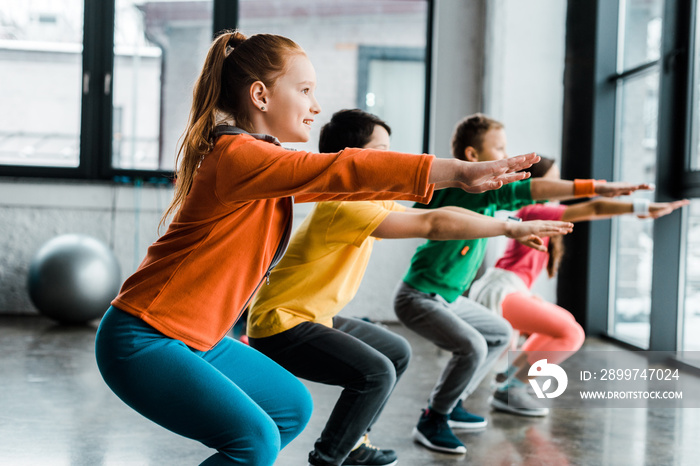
[608,0,663,348]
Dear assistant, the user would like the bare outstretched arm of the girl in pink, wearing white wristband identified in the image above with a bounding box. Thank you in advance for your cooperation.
[561,199,690,222]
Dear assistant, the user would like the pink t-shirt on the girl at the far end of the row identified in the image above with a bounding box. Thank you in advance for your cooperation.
[495,204,566,288]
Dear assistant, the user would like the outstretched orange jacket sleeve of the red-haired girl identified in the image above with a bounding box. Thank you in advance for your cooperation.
[209,135,434,203]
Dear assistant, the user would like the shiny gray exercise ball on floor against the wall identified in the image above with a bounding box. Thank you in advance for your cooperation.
[27,234,121,324]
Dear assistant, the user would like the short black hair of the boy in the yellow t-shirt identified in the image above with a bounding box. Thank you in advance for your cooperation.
[318,108,391,152]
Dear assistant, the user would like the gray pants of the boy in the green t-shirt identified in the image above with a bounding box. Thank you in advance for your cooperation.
[394,282,512,414]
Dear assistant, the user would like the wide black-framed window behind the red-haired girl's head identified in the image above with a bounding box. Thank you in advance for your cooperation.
[0,0,428,179]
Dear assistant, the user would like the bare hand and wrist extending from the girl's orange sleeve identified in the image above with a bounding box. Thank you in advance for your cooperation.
[428,153,540,193]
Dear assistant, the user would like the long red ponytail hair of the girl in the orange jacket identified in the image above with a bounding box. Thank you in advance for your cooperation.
[159,31,304,227]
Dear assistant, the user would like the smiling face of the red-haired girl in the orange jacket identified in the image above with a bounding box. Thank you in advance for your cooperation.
[264,54,321,142]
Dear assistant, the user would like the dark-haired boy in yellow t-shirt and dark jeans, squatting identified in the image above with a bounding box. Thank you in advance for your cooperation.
[247,110,571,466]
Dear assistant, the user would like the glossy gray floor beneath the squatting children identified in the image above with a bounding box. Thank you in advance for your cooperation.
[0,317,700,466]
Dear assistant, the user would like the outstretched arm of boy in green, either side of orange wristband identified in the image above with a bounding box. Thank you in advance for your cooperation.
[530,178,654,201]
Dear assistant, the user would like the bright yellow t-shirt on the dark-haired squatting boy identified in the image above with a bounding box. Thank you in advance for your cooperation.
[248,201,405,338]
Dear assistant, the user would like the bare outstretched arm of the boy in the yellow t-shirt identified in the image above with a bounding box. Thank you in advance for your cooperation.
[372,207,573,249]
